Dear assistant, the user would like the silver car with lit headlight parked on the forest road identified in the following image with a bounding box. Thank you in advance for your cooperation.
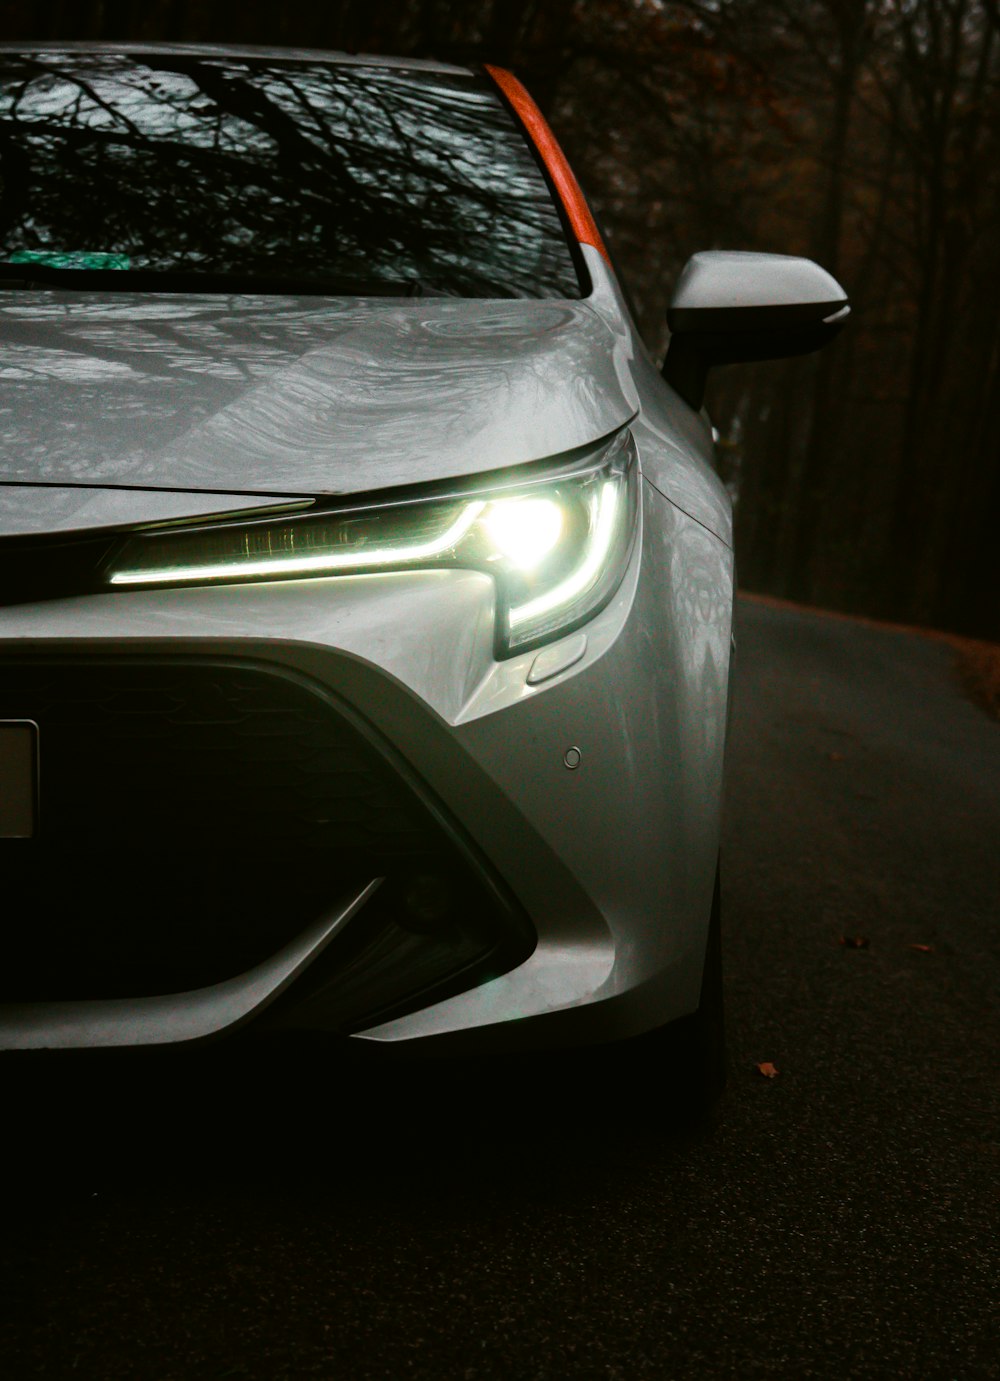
[0,44,848,1080]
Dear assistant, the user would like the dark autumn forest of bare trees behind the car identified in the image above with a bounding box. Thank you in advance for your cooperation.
[0,0,1000,639]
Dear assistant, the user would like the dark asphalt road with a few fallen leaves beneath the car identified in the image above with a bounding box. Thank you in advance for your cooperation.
[0,602,1000,1381]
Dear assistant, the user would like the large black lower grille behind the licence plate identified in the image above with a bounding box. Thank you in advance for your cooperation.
[0,659,502,1001]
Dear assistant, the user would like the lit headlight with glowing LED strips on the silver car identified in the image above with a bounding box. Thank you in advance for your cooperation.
[105,431,638,656]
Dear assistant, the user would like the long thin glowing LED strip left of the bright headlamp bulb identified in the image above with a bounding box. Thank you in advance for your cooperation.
[110,500,486,586]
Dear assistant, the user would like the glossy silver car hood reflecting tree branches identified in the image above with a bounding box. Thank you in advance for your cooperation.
[0,291,637,496]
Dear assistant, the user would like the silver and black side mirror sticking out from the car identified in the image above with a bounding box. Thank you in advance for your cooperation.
[663,250,851,412]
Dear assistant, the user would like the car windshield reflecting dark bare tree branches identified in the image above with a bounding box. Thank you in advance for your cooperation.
[0,51,580,297]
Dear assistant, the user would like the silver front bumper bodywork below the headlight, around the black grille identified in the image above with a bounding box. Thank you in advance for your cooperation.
[0,486,732,1048]
